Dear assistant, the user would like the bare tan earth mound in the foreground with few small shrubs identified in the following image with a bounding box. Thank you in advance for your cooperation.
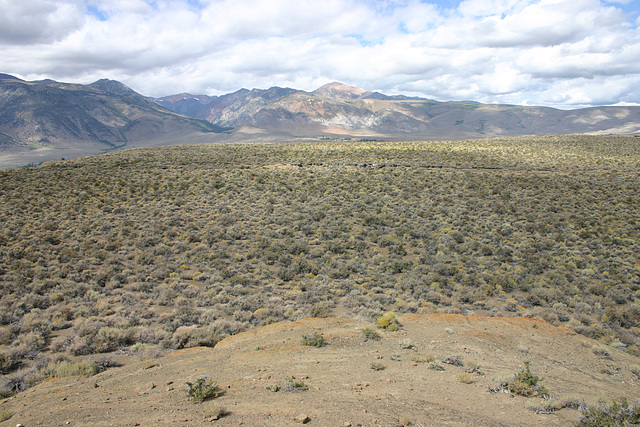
[0,314,640,427]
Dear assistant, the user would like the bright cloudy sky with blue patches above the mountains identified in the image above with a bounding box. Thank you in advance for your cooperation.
[0,0,640,109]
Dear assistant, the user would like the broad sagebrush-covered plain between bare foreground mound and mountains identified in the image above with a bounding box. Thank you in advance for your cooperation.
[0,136,640,396]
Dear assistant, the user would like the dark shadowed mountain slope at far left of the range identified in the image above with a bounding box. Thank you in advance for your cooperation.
[0,74,222,167]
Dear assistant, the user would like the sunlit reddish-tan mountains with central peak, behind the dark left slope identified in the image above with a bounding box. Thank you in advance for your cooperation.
[157,82,640,139]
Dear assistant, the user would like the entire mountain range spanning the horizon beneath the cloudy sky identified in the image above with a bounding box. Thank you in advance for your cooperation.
[0,74,640,167]
